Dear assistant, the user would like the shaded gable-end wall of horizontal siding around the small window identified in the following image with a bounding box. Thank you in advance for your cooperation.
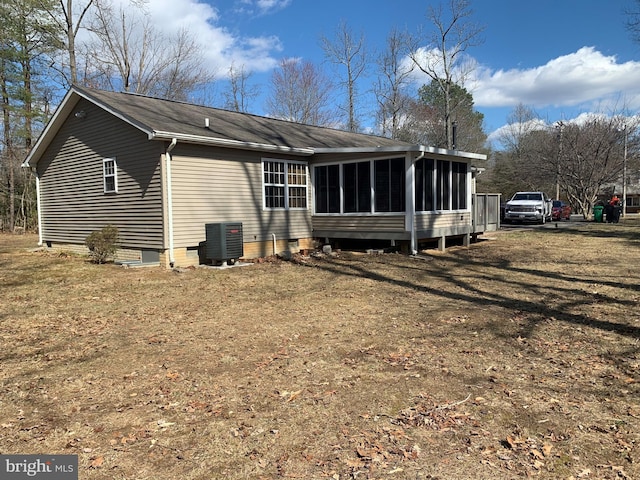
[37,100,164,249]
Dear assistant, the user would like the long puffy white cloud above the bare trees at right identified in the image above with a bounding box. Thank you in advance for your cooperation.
[470,47,640,108]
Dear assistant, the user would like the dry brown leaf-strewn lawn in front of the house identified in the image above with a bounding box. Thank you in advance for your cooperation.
[0,219,640,480]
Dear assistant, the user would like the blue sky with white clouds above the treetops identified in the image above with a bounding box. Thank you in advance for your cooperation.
[112,0,640,145]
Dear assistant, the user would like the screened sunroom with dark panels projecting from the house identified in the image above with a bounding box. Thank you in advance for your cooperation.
[310,147,484,255]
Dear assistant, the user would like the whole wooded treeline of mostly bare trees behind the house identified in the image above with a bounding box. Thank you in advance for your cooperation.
[0,0,638,231]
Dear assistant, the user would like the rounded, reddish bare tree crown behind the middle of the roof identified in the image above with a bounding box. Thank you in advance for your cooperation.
[267,58,336,126]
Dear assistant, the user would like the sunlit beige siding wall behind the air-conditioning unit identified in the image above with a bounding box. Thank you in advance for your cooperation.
[171,143,311,247]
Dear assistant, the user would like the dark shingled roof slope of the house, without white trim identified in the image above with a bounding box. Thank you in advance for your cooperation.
[76,88,411,148]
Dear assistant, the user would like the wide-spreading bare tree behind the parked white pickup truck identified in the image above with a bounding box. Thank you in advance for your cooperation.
[490,105,639,218]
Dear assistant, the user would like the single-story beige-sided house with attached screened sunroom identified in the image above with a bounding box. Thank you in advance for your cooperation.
[23,87,490,267]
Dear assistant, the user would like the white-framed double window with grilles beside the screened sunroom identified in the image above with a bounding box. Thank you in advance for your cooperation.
[262,160,308,209]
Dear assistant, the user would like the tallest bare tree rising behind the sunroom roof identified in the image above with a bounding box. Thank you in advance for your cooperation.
[409,0,483,149]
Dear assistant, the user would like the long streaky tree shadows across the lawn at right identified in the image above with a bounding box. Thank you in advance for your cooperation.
[300,240,640,338]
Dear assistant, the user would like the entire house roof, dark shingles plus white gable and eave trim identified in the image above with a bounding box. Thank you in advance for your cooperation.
[23,87,486,167]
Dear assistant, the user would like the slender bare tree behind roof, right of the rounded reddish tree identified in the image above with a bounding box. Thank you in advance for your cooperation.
[320,21,367,132]
